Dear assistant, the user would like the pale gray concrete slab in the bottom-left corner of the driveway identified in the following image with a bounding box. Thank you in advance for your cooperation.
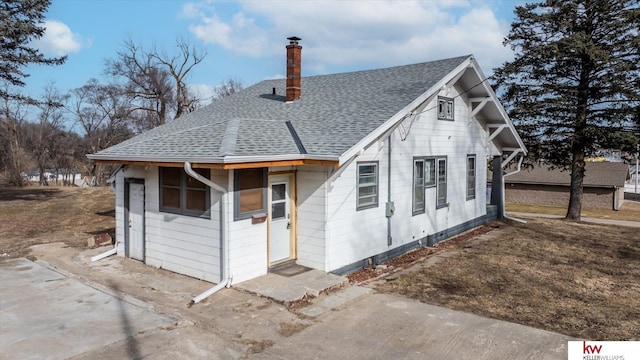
[0,259,176,359]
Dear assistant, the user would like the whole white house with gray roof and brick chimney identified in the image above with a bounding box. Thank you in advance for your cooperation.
[89,38,525,283]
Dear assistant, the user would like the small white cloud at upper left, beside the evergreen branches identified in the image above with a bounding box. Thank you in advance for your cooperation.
[33,20,91,56]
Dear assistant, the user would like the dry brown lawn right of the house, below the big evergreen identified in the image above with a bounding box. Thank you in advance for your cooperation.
[378,219,640,340]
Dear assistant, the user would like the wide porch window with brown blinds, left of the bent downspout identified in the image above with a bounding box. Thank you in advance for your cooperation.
[160,167,211,218]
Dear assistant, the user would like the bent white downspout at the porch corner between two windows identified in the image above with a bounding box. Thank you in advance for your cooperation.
[184,161,233,305]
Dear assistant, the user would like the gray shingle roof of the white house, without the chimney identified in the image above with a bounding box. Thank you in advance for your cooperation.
[90,56,469,162]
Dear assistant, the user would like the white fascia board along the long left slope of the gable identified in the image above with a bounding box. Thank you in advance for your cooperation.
[339,56,473,166]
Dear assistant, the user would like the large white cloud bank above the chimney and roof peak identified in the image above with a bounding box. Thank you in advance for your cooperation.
[185,0,511,75]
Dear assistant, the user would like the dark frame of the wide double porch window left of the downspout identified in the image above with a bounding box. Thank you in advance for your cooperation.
[158,166,211,219]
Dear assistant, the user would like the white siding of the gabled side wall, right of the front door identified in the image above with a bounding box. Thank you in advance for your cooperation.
[326,88,489,271]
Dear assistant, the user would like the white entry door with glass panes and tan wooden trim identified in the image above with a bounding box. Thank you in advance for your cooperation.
[269,176,294,265]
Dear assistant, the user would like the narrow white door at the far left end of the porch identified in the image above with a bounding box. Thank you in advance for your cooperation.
[127,182,144,261]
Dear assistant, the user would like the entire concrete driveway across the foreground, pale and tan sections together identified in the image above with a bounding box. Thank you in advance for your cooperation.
[0,248,569,360]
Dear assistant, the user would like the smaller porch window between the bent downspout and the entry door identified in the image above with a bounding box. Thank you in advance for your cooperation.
[233,168,267,220]
